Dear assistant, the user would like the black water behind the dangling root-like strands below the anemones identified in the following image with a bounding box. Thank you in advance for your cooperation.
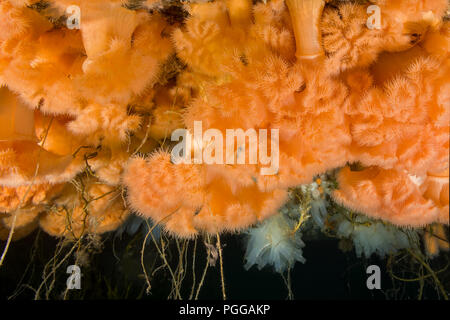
[0,232,446,300]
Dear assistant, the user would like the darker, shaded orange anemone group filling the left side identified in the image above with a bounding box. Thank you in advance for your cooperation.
[0,0,186,240]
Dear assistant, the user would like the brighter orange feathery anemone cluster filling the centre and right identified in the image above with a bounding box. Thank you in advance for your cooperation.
[124,0,450,237]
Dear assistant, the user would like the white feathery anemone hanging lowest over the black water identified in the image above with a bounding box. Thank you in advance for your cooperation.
[244,213,306,273]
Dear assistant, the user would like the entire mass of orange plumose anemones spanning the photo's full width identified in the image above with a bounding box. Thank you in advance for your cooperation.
[0,0,450,245]
